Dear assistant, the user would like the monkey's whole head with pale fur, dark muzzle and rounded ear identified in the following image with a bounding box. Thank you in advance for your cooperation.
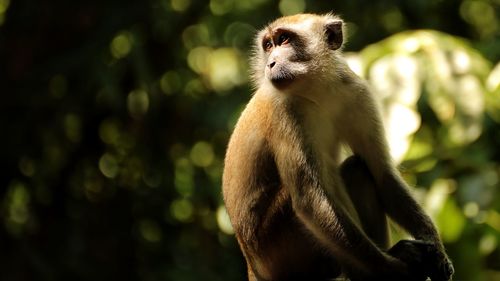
[252,14,344,90]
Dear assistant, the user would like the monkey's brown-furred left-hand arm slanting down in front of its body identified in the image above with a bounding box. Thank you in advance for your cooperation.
[276,144,411,280]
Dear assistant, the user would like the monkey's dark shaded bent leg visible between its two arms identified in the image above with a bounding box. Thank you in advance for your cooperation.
[340,155,389,249]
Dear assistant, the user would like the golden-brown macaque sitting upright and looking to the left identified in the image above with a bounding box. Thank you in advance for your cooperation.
[223,14,453,281]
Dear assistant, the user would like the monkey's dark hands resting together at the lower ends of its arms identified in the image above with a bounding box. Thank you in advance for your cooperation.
[388,240,454,281]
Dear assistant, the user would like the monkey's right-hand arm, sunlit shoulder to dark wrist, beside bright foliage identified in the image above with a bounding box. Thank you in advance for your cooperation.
[344,86,453,280]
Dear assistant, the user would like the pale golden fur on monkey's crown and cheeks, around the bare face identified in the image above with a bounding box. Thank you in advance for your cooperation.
[250,13,346,89]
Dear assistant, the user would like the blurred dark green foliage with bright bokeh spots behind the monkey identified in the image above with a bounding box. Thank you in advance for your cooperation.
[0,0,500,280]
